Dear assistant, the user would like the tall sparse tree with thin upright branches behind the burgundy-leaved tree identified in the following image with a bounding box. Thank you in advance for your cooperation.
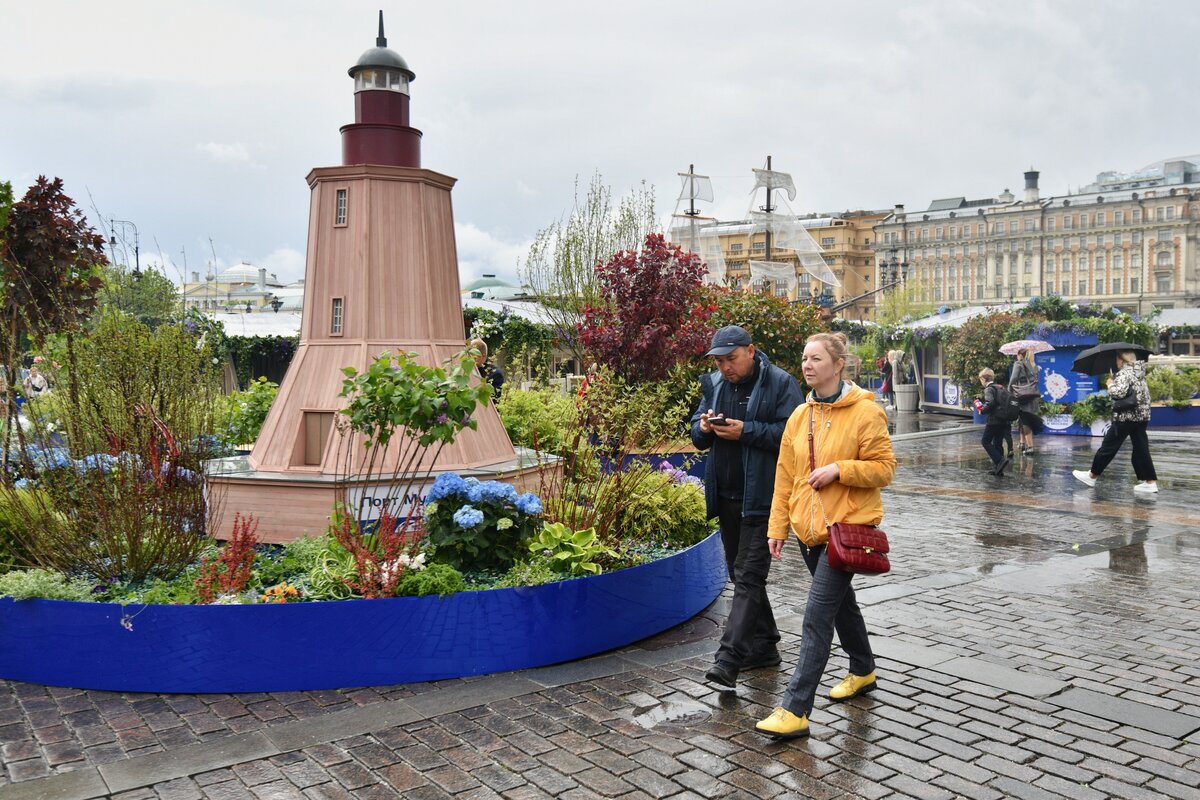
[521,173,659,361]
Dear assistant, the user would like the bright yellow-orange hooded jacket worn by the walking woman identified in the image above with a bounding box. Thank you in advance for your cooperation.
[767,381,896,547]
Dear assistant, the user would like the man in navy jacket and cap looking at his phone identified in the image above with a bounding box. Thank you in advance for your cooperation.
[691,325,803,688]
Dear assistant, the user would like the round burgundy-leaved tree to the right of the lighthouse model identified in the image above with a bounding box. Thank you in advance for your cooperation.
[578,234,716,381]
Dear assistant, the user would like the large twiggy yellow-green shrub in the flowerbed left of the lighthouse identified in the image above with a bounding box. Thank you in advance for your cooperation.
[0,312,221,582]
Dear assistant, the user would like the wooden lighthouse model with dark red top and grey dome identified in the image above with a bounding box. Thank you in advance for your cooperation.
[212,12,520,542]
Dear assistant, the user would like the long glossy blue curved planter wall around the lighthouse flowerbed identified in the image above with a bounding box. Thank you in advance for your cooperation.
[0,534,726,693]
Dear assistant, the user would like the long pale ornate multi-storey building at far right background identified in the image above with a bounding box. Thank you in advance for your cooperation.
[874,158,1200,314]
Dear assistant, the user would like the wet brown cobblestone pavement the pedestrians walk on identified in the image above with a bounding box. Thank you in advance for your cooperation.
[0,426,1200,800]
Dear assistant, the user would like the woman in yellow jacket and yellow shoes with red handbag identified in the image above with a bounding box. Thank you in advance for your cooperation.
[755,333,896,739]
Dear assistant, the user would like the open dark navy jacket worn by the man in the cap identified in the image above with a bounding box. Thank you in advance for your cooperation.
[691,350,804,517]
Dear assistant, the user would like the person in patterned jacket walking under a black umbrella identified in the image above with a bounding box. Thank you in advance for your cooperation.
[1072,342,1158,494]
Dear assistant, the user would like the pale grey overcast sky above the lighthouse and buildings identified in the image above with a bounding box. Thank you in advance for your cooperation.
[0,0,1200,287]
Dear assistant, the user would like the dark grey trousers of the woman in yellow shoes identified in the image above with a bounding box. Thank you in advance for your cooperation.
[784,543,875,716]
